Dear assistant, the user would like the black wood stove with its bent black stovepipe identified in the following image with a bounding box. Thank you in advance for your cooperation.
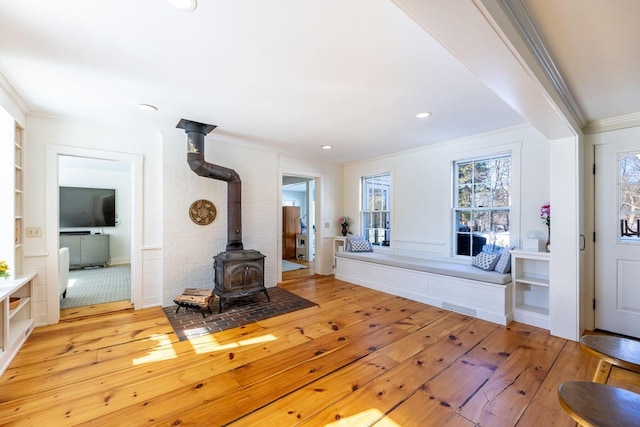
[177,119,271,312]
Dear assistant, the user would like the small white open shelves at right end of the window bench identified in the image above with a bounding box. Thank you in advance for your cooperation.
[511,249,551,329]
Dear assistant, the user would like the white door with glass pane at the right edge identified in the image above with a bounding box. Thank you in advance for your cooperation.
[595,141,640,338]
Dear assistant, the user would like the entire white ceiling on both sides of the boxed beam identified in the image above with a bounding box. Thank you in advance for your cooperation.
[0,0,640,162]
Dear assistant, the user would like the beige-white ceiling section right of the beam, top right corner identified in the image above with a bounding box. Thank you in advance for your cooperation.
[521,0,640,122]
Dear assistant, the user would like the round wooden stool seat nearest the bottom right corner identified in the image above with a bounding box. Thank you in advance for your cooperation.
[558,382,640,427]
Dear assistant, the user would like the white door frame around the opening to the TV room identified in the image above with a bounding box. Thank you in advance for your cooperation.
[45,144,144,325]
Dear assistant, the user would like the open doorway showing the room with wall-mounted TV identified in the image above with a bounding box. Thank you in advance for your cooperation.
[58,155,132,309]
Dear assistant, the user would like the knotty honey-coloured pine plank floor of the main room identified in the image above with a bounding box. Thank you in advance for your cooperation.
[0,276,640,427]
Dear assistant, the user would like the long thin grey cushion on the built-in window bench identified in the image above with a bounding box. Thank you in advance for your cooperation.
[336,252,511,285]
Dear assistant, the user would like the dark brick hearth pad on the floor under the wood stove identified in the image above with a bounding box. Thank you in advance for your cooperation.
[163,287,317,341]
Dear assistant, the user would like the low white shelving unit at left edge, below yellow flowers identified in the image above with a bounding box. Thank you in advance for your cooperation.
[0,273,36,375]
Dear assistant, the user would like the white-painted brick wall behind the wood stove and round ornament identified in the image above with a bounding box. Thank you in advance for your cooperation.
[163,130,278,306]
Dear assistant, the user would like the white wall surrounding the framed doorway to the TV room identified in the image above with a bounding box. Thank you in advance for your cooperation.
[24,116,162,324]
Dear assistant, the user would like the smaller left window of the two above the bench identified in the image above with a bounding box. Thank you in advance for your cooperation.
[360,172,391,246]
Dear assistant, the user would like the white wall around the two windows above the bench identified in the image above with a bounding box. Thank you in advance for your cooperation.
[344,126,550,258]
